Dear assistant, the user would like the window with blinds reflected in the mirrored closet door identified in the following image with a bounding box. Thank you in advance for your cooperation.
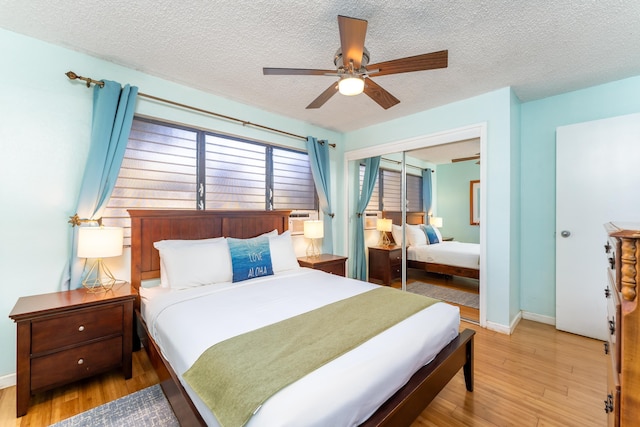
[360,165,423,212]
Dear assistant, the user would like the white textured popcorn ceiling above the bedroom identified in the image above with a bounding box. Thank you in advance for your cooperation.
[0,0,640,132]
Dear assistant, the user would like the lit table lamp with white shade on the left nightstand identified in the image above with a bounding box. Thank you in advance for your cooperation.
[78,227,123,292]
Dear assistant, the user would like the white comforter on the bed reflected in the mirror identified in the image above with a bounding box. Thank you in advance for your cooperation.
[407,242,480,270]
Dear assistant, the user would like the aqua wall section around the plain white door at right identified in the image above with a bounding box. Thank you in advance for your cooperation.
[519,76,640,317]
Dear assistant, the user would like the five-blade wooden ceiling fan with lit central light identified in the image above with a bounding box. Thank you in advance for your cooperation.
[262,15,448,110]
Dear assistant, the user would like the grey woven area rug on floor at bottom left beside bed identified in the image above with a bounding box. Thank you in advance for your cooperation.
[52,384,180,427]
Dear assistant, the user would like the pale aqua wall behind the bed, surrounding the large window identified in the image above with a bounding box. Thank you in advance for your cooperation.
[0,30,344,380]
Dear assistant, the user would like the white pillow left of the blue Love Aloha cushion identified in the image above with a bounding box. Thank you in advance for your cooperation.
[154,239,233,289]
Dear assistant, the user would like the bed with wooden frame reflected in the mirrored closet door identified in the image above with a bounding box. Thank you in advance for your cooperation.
[382,211,480,279]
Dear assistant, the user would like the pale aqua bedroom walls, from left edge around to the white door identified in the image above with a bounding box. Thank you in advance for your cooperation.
[0,25,640,386]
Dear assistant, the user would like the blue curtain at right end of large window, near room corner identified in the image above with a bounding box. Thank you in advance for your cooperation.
[307,136,334,254]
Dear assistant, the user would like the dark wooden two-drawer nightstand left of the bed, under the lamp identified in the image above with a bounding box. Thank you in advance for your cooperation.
[9,283,136,417]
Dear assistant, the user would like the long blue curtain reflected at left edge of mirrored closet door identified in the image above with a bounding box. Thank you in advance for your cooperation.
[353,156,380,280]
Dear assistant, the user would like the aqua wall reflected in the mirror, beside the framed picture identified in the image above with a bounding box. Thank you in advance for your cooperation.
[434,160,480,243]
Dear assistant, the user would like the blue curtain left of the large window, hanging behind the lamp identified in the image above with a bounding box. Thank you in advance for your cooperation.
[62,80,138,289]
